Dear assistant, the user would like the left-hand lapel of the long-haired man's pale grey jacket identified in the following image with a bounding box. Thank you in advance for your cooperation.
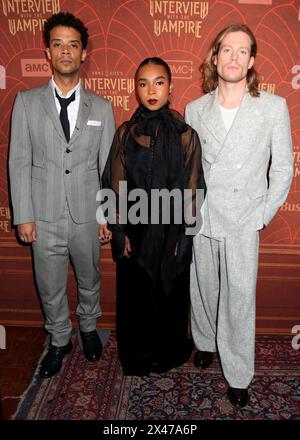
[200,88,227,148]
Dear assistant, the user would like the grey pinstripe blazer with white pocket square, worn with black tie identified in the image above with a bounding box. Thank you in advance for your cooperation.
[9,82,115,224]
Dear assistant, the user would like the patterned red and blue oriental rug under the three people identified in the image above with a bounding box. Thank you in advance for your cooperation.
[14,331,300,421]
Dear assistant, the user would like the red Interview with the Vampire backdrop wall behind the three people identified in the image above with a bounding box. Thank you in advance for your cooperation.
[0,0,300,332]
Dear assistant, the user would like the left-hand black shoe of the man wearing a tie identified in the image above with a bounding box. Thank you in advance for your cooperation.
[40,340,73,379]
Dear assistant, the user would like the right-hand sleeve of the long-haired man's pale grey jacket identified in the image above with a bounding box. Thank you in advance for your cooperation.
[264,99,293,225]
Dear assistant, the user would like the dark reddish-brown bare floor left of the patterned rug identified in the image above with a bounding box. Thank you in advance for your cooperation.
[0,327,47,420]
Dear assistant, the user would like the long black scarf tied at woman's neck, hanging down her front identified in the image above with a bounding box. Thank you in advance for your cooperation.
[132,104,187,294]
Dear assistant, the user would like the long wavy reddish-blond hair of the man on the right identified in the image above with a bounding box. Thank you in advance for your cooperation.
[200,24,259,97]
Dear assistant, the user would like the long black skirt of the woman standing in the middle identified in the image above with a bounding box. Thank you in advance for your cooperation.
[116,257,194,376]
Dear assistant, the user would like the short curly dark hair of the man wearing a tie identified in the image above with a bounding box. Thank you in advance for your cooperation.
[44,12,89,49]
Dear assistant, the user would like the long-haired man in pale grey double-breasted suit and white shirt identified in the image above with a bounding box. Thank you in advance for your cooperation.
[186,25,293,407]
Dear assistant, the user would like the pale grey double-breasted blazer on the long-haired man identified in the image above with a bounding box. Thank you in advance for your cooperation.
[185,89,293,237]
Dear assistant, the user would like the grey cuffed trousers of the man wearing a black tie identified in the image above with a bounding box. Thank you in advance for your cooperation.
[32,204,101,347]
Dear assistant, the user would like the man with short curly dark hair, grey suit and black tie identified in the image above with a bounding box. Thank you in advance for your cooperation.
[9,13,115,378]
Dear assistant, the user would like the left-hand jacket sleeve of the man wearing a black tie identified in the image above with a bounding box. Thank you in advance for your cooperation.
[9,93,34,225]
